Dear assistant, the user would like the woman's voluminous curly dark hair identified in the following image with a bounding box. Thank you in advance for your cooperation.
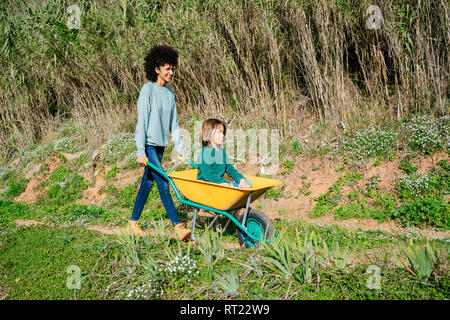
[144,46,178,82]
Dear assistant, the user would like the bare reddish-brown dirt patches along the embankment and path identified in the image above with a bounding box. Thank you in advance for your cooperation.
[15,153,450,238]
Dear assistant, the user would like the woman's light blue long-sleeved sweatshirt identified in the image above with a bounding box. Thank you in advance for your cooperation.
[134,81,184,157]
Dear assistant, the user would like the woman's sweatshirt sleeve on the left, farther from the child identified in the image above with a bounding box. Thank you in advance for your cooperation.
[134,86,151,157]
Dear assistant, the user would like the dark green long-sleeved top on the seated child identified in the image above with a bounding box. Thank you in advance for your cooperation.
[197,146,244,183]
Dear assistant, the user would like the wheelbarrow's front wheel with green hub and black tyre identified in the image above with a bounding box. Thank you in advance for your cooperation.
[237,208,274,248]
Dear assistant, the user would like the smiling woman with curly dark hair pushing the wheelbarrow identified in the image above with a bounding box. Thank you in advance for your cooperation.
[129,46,191,240]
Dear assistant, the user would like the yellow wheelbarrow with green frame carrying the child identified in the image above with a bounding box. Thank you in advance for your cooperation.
[146,159,282,248]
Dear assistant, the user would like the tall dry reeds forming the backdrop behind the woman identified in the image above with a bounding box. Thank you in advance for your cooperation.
[0,0,450,159]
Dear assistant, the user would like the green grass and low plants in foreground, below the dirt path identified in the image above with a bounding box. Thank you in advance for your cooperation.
[0,220,450,300]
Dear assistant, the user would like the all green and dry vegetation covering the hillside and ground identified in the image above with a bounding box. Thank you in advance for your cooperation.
[0,0,450,300]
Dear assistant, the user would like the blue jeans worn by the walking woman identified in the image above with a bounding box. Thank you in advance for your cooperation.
[131,145,180,225]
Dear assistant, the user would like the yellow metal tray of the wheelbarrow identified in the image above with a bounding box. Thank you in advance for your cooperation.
[167,169,282,211]
